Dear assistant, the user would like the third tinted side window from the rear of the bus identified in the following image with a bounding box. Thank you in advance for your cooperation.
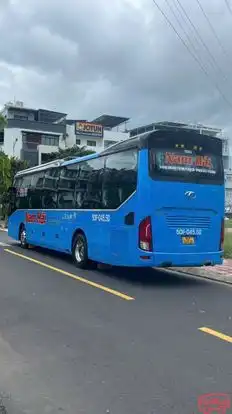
[57,164,79,209]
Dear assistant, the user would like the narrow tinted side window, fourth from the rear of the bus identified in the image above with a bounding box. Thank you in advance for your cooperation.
[42,168,60,209]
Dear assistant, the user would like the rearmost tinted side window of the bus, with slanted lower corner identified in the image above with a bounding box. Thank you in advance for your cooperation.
[103,150,137,209]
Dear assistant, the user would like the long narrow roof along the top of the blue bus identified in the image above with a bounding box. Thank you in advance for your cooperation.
[16,128,222,177]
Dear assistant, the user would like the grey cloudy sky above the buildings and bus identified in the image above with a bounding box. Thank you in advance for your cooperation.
[0,0,232,129]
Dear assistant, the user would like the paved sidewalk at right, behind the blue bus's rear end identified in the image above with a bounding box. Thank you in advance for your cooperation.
[170,259,232,284]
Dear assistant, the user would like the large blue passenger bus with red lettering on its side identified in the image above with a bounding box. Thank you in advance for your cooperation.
[8,130,224,268]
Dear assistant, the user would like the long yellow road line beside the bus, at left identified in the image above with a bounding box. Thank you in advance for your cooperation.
[4,249,135,300]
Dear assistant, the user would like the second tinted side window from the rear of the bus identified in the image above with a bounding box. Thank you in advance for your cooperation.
[76,157,104,209]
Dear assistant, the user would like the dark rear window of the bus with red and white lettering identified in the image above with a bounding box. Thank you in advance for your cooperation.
[150,143,223,184]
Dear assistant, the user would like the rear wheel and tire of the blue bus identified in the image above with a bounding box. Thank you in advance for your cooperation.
[72,232,90,269]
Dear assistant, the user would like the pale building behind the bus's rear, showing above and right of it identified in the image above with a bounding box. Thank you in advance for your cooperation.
[130,122,232,210]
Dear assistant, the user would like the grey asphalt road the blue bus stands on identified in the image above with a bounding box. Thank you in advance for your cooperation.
[0,232,232,414]
